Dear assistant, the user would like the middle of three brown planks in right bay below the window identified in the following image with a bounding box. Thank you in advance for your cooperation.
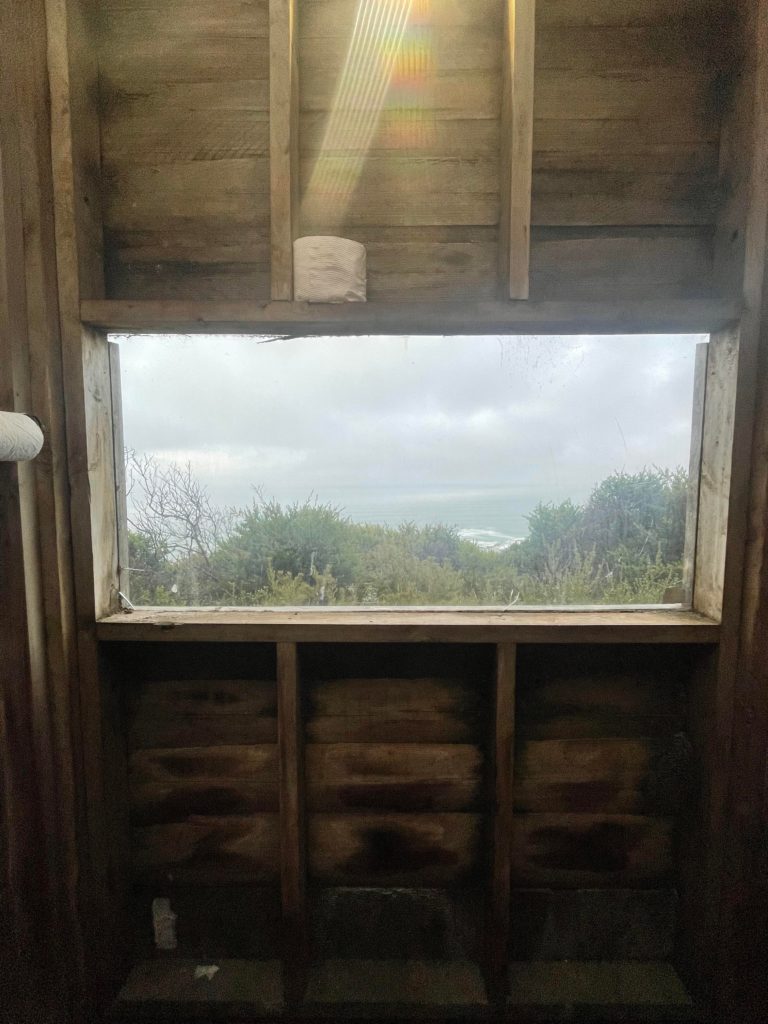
[514,741,692,814]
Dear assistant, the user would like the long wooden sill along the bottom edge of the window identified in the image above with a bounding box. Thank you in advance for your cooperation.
[96,608,720,644]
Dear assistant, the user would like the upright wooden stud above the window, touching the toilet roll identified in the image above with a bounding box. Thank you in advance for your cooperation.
[269,0,299,301]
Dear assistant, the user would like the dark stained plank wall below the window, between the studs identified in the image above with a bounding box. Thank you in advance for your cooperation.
[104,643,703,974]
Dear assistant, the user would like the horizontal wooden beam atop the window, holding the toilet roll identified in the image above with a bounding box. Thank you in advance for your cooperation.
[81,299,740,338]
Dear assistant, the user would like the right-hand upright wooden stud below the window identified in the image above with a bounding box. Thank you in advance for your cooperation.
[488,643,516,1000]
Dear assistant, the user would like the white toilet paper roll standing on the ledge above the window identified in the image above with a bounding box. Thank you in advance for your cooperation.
[293,234,367,302]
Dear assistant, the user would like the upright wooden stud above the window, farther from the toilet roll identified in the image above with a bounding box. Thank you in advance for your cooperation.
[499,0,536,299]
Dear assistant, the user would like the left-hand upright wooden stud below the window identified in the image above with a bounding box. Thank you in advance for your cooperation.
[278,643,309,1006]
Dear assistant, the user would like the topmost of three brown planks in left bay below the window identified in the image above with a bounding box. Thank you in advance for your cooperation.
[128,679,278,750]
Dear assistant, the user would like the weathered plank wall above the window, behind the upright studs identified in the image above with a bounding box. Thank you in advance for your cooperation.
[99,0,730,300]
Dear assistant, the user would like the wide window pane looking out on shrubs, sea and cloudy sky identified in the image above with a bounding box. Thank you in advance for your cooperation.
[112,335,705,608]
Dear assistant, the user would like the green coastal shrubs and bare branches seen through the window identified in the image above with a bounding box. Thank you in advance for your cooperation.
[127,454,688,607]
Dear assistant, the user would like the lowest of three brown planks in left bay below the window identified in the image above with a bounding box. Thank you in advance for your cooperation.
[133,814,281,885]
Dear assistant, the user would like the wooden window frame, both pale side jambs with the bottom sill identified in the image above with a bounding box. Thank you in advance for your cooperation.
[85,323,739,643]
